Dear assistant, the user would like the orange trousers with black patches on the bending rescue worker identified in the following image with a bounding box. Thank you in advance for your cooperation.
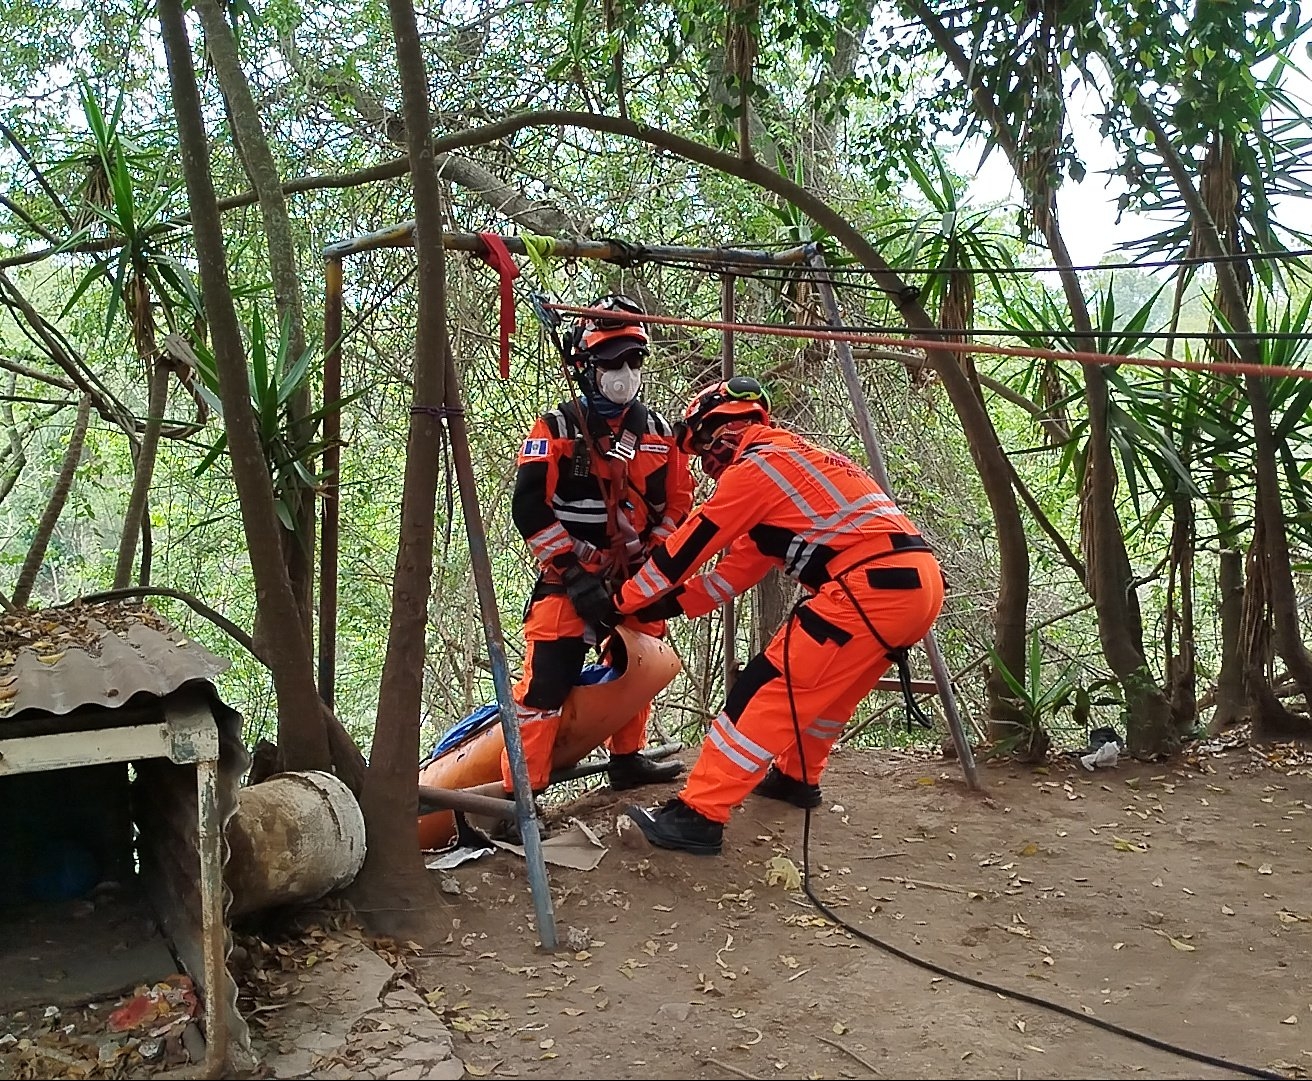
[678,551,943,823]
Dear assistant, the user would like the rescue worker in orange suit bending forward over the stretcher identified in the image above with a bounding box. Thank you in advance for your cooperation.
[617,377,943,855]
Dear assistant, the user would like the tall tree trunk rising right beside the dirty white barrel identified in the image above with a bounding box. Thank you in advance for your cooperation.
[352,0,454,934]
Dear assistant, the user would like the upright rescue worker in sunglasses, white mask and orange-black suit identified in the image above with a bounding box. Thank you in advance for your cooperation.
[501,295,694,794]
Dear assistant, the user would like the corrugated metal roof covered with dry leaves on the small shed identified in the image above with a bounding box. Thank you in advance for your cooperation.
[0,601,231,722]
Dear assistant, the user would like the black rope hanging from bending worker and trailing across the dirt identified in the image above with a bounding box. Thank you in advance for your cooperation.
[783,597,1284,1081]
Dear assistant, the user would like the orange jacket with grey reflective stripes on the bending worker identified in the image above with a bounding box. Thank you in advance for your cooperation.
[618,424,918,617]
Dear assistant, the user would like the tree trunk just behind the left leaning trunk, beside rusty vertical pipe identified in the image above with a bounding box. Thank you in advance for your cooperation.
[195,0,315,651]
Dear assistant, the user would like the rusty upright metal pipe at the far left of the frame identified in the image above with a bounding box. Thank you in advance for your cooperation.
[319,258,342,710]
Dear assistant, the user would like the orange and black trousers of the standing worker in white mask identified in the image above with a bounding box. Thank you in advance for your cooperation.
[501,593,665,792]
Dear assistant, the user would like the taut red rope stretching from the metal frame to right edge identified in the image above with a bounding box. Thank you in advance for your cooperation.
[543,303,1312,379]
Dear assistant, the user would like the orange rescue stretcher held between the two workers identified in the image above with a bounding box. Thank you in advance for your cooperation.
[419,626,682,849]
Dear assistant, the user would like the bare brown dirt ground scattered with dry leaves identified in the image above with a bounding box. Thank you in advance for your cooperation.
[411,746,1312,1078]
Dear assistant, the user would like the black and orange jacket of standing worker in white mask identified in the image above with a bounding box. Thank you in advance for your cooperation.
[512,403,693,577]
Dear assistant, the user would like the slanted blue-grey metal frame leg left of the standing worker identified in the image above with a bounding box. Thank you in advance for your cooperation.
[446,362,556,950]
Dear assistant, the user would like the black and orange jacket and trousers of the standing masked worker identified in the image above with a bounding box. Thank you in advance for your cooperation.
[501,399,693,791]
